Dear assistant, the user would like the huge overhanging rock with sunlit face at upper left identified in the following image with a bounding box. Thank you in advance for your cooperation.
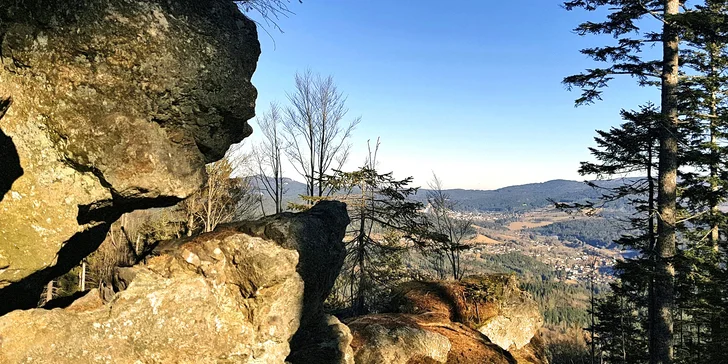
[0,0,260,314]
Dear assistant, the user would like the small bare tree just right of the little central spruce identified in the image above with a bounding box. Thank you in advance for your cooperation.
[427,173,473,280]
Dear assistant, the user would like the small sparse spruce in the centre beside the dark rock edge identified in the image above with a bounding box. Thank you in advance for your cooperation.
[325,141,430,315]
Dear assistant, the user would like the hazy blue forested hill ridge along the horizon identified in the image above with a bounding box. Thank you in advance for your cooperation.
[250,178,636,212]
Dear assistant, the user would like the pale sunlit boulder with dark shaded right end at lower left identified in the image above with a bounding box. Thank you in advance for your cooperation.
[0,202,351,364]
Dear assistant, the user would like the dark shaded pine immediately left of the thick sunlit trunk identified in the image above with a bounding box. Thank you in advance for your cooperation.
[579,104,660,363]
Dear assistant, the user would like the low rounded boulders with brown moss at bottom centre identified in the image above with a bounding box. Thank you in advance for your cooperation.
[347,275,548,364]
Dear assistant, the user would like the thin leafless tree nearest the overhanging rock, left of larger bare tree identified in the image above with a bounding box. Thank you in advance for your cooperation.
[253,103,285,215]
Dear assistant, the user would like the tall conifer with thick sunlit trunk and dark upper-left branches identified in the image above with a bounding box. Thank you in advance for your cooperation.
[564,0,683,364]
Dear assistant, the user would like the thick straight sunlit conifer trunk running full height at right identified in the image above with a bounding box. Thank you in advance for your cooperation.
[650,0,680,364]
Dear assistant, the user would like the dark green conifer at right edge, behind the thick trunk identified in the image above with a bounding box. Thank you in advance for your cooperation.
[675,4,728,362]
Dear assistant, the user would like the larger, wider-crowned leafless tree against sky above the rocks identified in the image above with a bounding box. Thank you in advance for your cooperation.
[283,70,361,197]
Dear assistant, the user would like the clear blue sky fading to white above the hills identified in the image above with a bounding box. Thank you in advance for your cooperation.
[240,0,658,189]
